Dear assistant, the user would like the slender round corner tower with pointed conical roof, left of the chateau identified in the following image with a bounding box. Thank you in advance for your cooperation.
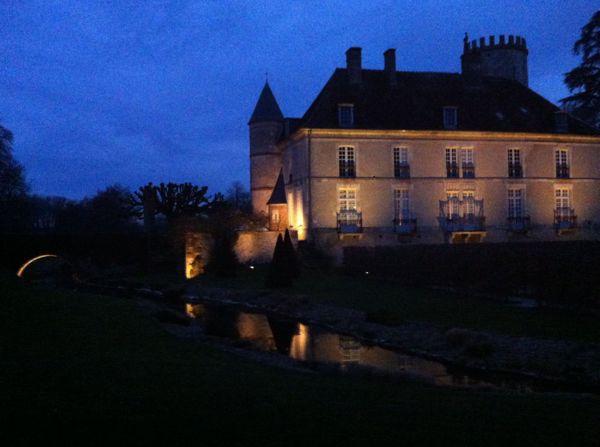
[248,82,283,214]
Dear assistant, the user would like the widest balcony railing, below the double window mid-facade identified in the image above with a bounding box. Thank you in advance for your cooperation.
[439,198,485,233]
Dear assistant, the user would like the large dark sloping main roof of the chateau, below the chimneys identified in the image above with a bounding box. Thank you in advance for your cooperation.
[299,68,600,135]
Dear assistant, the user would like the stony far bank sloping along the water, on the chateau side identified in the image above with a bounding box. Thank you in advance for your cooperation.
[183,286,600,392]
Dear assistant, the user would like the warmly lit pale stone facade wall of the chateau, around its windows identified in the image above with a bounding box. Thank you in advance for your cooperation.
[283,130,600,254]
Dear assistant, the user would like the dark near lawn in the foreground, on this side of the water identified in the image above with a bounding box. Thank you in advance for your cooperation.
[0,272,600,446]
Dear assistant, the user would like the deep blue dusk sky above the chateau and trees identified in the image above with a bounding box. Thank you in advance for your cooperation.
[0,0,598,198]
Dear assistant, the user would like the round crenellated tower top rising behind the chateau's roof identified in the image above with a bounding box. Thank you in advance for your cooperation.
[460,34,528,86]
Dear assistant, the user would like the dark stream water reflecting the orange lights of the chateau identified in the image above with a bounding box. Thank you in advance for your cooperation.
[186,304,464,385]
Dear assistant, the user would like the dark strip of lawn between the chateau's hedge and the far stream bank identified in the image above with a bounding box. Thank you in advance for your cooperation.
[196,266,600,343]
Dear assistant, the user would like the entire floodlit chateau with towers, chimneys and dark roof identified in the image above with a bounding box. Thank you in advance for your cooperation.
[249,35,600,256]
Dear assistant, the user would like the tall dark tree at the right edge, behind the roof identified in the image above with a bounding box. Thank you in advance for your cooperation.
[561,10,600,127]
